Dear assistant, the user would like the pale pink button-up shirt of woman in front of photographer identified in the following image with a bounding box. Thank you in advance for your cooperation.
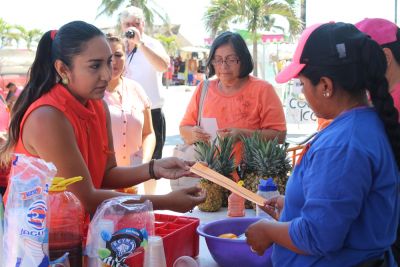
[104,78,151,166]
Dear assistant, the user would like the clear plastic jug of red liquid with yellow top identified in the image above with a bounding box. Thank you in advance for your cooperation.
[48,177,85,266]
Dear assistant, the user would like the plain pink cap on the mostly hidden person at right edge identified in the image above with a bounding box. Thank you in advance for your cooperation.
[354,18,398,45]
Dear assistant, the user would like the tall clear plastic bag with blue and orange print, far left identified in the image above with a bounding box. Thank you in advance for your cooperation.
[3,154,57,267]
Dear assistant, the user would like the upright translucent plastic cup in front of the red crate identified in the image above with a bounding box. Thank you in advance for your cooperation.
[143,236,167,267]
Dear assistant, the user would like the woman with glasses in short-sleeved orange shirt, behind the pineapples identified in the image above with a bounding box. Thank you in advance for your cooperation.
[180,32,286,161]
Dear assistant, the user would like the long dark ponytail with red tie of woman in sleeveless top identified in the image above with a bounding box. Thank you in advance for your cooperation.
[0,21,104,164]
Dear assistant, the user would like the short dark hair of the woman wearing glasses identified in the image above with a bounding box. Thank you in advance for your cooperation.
[207,31,254,78]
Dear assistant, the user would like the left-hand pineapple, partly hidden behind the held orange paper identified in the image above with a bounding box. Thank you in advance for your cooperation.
[195,137,235,211]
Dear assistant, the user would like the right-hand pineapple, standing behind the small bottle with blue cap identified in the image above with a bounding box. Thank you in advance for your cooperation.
[241,132,291,208]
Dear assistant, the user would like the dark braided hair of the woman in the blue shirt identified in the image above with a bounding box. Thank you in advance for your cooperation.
[301,36,400,167]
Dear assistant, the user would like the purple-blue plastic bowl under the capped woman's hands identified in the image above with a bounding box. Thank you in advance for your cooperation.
[197,218,272,267]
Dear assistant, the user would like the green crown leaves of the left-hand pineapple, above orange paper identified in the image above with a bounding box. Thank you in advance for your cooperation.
[195,136,235,177]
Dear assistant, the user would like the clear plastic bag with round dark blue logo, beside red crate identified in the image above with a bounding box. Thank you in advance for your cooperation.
[86,196,154,267]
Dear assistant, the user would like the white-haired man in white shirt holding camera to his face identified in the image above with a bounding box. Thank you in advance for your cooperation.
[119,6,170,159]
